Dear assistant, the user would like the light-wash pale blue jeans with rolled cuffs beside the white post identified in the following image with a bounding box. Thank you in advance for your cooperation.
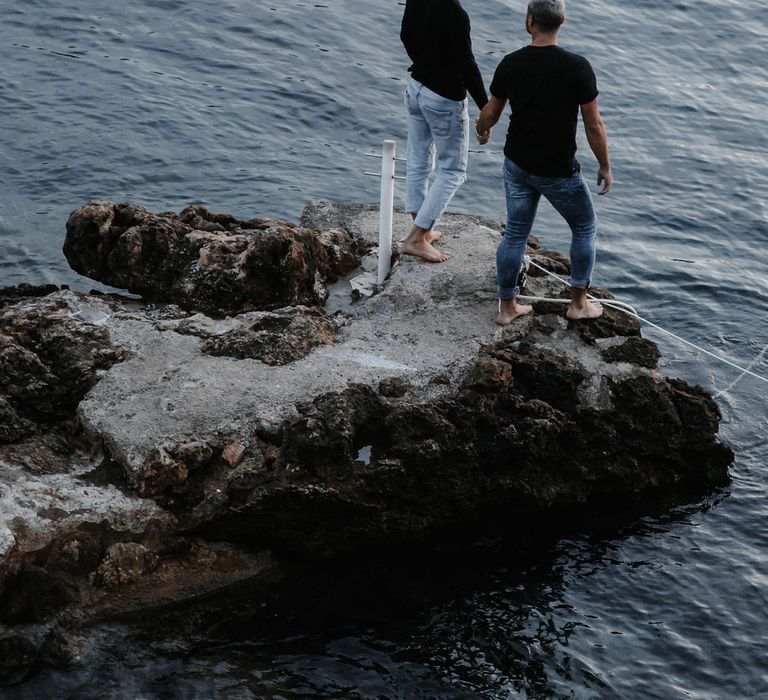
[405,78,469,231]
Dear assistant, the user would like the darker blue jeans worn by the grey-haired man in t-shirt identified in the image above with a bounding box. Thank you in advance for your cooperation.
[496,158,597,299]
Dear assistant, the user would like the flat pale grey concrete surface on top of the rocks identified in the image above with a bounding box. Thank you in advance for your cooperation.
[76,205,528,470]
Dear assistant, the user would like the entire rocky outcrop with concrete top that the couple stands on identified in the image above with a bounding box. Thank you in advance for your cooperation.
[0,204,732,684]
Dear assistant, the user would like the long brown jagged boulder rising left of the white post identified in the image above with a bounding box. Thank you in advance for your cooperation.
[64,202,360,315]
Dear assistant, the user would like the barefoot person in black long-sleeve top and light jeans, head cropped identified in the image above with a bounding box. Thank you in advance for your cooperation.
[400,0,488,262]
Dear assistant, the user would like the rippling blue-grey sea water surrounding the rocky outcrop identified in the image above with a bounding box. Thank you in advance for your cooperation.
[0,0,768,700]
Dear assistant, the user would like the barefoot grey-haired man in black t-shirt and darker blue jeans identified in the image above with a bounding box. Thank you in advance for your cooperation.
[475,0,613,326]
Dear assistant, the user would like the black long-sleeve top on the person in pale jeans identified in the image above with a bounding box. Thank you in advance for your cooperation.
[400,0,488,109]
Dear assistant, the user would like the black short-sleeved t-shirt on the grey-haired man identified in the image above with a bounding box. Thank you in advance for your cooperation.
[491,46,598,177]
